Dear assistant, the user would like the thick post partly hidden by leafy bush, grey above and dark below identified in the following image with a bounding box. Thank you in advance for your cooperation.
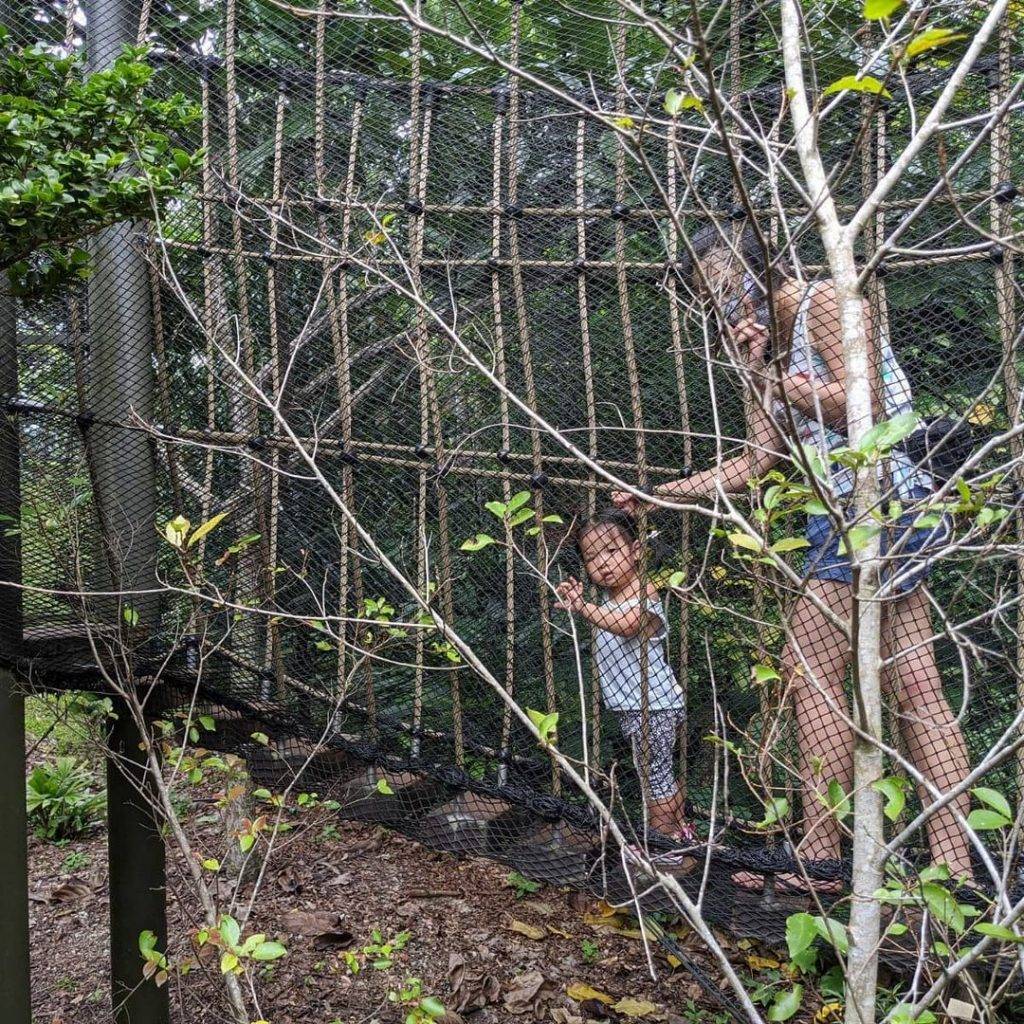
[83,0,170,1024]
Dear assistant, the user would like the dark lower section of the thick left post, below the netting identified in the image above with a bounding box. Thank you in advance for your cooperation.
[107,702,171,1024]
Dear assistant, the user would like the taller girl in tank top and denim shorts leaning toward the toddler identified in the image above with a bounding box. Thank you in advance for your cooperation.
[612,222,973,895]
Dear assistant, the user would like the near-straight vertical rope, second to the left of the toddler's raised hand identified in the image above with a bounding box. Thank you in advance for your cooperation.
[490,91,516,785]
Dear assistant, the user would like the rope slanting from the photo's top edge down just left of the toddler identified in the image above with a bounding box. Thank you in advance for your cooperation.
[508,3,561,795]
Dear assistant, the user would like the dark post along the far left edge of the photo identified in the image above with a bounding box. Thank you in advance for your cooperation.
[0,266,32,1024]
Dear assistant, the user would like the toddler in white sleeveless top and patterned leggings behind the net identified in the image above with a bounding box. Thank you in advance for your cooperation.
[557,510,696,846]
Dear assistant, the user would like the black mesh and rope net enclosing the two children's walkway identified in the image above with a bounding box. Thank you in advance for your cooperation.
[3,0,1024,958]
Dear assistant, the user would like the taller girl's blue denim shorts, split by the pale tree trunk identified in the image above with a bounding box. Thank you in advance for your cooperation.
[805,490,952,596]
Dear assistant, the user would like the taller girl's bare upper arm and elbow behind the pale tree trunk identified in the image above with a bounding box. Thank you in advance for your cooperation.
[782,282,883,428]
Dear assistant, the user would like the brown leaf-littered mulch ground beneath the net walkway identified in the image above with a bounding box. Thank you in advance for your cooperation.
[24,696,785,1024]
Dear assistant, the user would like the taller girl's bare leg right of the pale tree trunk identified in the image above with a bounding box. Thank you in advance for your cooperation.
[885,588,973,878]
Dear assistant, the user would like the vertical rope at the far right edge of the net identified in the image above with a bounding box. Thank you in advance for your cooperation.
[989,22,1024,787]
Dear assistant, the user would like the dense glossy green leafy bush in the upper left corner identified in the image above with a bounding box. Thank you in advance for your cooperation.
[0,28,198,297]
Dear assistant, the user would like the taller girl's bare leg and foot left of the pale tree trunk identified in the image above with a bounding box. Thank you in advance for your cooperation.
[733,580,853,891]
